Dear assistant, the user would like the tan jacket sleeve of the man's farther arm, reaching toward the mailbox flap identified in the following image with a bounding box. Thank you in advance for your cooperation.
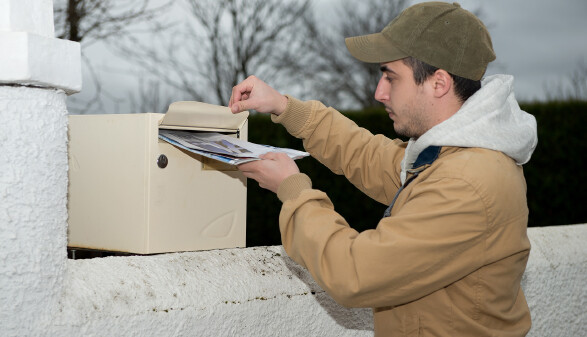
[272,97,405,204]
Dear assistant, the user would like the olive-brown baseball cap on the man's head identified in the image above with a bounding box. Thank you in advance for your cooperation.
[345,2,495,80]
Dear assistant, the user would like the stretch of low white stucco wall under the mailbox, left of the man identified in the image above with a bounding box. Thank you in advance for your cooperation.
[55,246,372,336]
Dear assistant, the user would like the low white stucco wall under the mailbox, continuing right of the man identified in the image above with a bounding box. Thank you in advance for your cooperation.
[28,225,587,337]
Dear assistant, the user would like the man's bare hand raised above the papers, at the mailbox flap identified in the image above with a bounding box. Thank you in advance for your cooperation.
[228,76,287,116]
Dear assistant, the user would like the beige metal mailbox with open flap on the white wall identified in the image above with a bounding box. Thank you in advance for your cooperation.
[68,102,248,254]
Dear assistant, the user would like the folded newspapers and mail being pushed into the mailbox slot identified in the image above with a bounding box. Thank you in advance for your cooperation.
[159,129,310,165]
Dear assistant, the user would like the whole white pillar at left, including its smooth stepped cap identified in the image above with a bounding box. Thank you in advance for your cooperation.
[0,0,81,336]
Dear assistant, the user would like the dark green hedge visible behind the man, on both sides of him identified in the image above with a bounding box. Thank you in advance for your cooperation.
[247,102,587,246]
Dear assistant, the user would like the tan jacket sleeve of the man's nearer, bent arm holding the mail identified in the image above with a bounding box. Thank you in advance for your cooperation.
[278,174,486,307]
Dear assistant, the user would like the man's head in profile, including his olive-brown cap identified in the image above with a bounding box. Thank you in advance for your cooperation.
[346,2,495,138]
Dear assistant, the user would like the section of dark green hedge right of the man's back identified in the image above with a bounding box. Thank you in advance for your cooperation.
[522,101,587,227]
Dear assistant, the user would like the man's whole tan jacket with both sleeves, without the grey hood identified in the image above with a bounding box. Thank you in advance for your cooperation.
[273,98,531,337]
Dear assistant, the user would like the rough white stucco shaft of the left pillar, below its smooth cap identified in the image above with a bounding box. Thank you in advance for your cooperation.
[0,86,67,336]
